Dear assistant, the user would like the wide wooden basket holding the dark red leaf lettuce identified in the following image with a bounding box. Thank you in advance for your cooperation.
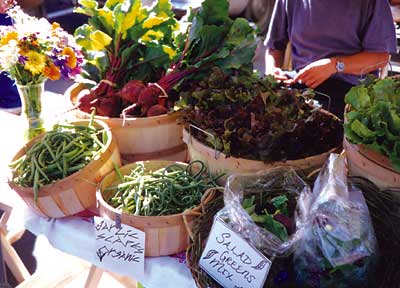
[183,129,339,185]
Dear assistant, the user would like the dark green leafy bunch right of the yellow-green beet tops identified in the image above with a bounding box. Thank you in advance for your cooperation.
[177,0,257,79]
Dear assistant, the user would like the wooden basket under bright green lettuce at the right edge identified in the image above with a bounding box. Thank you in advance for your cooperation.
[343,138,400,189]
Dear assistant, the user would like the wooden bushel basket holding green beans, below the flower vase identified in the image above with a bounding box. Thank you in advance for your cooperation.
[9,120,121,218]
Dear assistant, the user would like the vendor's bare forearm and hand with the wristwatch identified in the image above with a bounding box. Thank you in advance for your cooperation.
[293,51,389,88]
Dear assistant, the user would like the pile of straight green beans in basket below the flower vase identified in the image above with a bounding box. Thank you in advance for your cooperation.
[10,122,107,201]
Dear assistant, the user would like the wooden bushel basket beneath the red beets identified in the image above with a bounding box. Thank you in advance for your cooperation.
[65,84,187,163]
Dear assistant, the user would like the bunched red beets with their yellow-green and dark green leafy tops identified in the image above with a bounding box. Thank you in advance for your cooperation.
[75,0,256,117]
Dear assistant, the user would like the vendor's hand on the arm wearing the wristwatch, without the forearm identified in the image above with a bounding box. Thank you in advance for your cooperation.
[293,58,336,88]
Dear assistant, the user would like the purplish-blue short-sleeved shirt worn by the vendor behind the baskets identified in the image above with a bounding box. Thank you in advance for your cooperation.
[265,0,396,84]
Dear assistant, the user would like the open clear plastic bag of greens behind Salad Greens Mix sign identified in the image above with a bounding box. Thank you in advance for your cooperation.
[217,167,311,260]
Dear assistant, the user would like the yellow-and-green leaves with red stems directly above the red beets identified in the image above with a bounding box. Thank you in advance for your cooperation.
[75,0,179,87]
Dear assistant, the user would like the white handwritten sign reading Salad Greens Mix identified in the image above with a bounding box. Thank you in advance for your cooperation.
[199,218,271,288]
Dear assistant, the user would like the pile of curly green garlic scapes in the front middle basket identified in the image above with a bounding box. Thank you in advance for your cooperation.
[105,160,223,216]
